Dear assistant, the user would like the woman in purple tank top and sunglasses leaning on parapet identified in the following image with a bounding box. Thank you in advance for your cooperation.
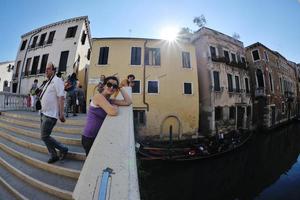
[81,76,132,156]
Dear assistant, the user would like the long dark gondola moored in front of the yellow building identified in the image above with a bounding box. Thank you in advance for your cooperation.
[136,130,252,161]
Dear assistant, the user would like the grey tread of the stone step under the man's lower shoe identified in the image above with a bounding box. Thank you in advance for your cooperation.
[0,137,84,171]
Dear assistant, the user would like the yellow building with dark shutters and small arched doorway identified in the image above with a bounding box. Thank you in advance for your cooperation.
[87,38,199,140]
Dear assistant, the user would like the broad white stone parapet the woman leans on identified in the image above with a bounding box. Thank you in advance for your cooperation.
[73,88,140,200]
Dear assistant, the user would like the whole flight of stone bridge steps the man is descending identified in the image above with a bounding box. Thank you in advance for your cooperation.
[0,111,85,200]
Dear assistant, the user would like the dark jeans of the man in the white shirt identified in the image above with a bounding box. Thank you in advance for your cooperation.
[41,114,68,158]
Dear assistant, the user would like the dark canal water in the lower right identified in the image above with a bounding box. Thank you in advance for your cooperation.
[139,122,300,200]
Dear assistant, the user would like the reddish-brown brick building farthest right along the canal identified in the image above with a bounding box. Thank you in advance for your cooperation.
[246,43,297,129]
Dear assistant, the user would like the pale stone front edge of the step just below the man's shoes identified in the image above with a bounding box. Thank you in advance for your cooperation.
[0,143,80,180]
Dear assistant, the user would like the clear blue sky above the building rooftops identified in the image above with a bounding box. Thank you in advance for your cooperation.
[0,0,300,63]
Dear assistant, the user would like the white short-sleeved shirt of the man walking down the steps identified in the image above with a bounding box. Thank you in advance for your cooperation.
[41,75,64,119]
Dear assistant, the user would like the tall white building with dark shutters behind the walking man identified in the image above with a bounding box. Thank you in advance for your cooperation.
[12,16,91,94]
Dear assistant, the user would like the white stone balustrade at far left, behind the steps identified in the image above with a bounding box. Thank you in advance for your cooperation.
[0,92,31,111]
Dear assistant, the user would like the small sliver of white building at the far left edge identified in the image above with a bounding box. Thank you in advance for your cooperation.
[0,61,15,92]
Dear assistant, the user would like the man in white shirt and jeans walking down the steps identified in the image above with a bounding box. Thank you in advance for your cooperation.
[41,63,68,163]
